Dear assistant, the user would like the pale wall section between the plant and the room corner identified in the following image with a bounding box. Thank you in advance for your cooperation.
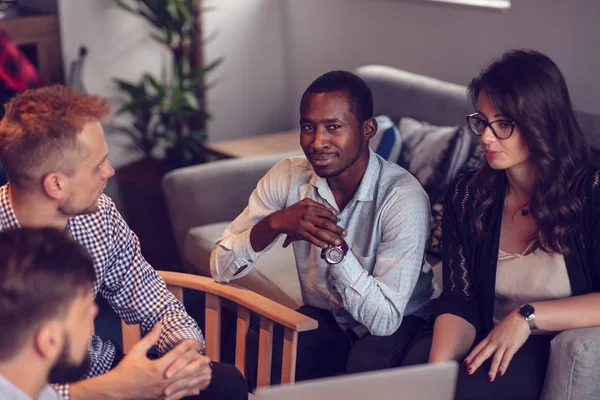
[203,0,290,140]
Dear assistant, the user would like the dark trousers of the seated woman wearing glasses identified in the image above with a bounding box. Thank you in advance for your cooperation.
[402,333,552,400]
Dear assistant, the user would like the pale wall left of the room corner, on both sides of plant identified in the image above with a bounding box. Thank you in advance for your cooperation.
[59,0,290,160]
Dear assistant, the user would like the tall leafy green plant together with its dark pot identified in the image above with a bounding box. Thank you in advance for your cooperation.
[108,0,221,269]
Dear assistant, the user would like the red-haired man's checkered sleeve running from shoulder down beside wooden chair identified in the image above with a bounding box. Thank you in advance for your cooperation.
[100,196,204,354]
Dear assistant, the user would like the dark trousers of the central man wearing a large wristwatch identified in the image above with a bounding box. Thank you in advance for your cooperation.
[246,306,425,390]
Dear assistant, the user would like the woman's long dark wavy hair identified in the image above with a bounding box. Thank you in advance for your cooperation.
[469,50,590,254]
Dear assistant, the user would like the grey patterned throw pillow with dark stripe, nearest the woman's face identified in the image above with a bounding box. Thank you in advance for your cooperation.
[398,118,477,257]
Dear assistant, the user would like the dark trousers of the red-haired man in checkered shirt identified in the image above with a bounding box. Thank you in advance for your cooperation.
[111,351,248,400]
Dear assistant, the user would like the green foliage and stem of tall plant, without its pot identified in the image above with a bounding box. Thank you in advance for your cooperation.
[113,0,222,169]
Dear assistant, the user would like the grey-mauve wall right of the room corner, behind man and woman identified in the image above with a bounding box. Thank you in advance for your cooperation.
[284,0,600,123]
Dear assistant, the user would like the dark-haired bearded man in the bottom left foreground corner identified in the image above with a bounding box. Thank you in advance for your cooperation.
[0,228,98,400]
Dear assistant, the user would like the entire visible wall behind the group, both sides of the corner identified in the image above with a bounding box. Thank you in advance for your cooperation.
[59,0,600,154]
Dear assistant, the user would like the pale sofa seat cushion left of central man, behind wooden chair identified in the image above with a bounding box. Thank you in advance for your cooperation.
[184,222,303,310]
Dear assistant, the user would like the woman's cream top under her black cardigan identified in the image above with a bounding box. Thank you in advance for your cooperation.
[494,245,571,325]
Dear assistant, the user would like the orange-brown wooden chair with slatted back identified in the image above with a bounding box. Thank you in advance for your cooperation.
[121,271,318,387]
